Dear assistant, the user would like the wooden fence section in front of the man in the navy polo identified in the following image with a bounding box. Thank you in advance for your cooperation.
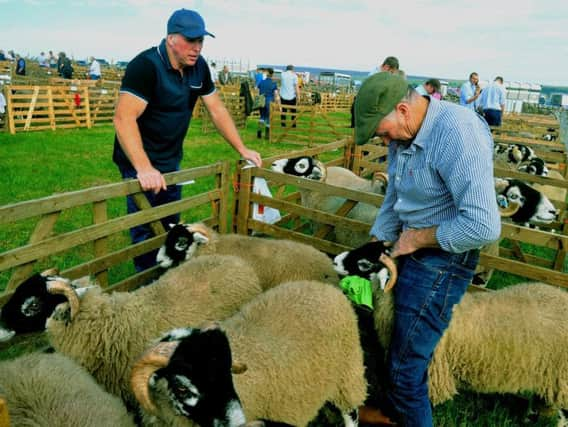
[0,162,229,304]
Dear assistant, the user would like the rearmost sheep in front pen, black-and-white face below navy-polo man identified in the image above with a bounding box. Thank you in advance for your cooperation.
[157,223,339,290]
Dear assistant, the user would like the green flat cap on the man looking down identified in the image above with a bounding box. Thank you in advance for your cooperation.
[355,71,408,145]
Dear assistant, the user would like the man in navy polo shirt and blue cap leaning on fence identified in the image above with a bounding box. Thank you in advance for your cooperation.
[113,9,262,271]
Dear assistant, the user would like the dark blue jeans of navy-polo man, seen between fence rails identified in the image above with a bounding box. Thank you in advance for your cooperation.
[120,169,181,272]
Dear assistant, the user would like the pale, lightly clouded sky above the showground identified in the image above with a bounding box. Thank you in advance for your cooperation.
[0,0,568,86]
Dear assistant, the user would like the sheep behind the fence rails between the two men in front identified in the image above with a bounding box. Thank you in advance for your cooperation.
[271,156,388,247]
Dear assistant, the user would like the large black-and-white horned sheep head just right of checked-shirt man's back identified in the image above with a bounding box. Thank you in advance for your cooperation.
[494,178,558,225]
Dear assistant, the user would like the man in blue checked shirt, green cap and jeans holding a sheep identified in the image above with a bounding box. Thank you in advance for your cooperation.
[355,72,501,427]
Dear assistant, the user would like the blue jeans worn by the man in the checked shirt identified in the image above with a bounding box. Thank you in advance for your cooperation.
[385,249,479,427]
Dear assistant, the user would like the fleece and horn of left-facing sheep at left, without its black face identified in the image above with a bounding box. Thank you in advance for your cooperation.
[46,256,262,403]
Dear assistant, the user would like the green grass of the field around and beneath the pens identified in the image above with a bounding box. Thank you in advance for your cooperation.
[0,121,555,427]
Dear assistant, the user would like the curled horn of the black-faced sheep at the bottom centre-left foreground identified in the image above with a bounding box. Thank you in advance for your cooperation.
[130,341,179,412]
